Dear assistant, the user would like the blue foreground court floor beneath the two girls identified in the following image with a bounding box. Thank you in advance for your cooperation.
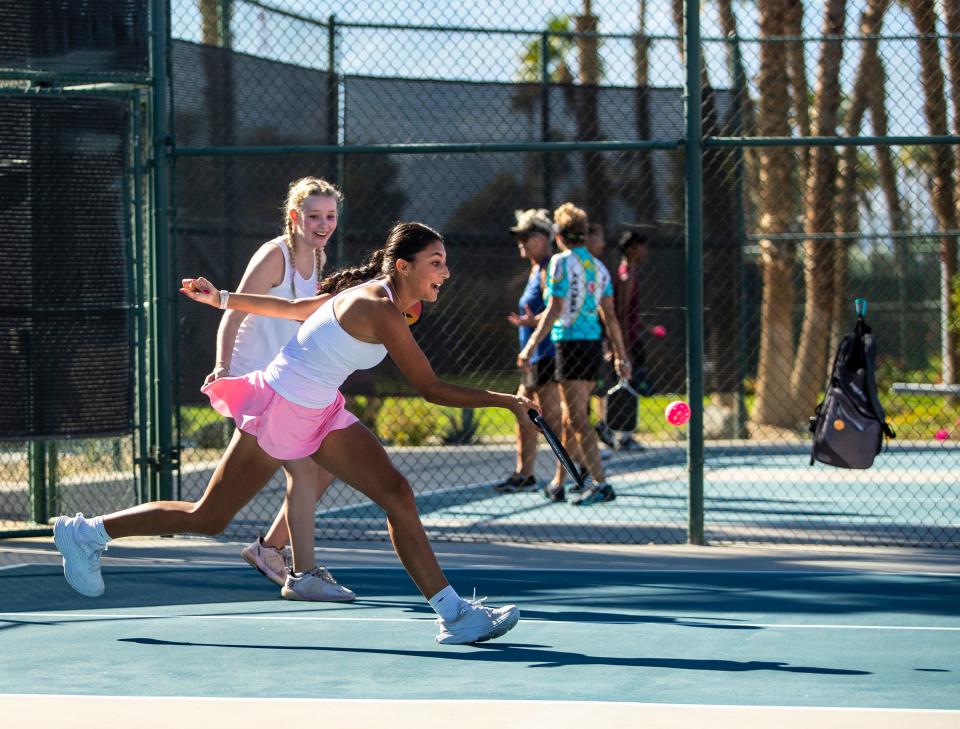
[0,538,960,729]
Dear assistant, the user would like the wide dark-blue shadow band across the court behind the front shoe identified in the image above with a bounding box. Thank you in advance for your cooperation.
[0,560,960,616]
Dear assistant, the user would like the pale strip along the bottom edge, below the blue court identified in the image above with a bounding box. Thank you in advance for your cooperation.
[0,694,960,729]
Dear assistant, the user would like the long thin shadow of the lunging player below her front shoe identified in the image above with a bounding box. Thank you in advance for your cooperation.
[117,638,871,676]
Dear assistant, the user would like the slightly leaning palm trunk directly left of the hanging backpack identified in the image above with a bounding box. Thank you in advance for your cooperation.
[790,0,847,409]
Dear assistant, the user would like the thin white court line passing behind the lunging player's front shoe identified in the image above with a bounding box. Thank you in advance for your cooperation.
[0,612,960,633]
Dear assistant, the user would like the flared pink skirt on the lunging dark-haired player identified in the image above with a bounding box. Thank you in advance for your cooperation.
[200,370,357,461]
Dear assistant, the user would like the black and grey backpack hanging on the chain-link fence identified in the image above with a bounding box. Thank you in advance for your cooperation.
[810,299,896,468]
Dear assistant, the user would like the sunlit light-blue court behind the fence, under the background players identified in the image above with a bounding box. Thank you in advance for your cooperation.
[290,443,960,545]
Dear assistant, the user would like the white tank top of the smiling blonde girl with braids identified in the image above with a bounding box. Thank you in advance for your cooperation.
[230,236,318,375]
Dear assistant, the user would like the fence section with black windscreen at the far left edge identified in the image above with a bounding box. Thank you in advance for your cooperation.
[0,0,149,534]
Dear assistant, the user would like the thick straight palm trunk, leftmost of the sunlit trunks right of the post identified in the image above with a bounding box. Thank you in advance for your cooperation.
[751,0,797,427]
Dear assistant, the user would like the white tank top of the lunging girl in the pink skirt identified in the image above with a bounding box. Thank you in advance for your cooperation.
[263,280,393,408]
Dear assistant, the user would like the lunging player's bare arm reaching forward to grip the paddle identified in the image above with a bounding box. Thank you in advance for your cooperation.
[374,306,540,418]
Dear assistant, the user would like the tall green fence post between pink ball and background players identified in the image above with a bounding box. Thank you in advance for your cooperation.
[683,0,704,544]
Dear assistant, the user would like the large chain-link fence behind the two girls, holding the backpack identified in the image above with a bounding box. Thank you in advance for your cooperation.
[1,0,960,546]
